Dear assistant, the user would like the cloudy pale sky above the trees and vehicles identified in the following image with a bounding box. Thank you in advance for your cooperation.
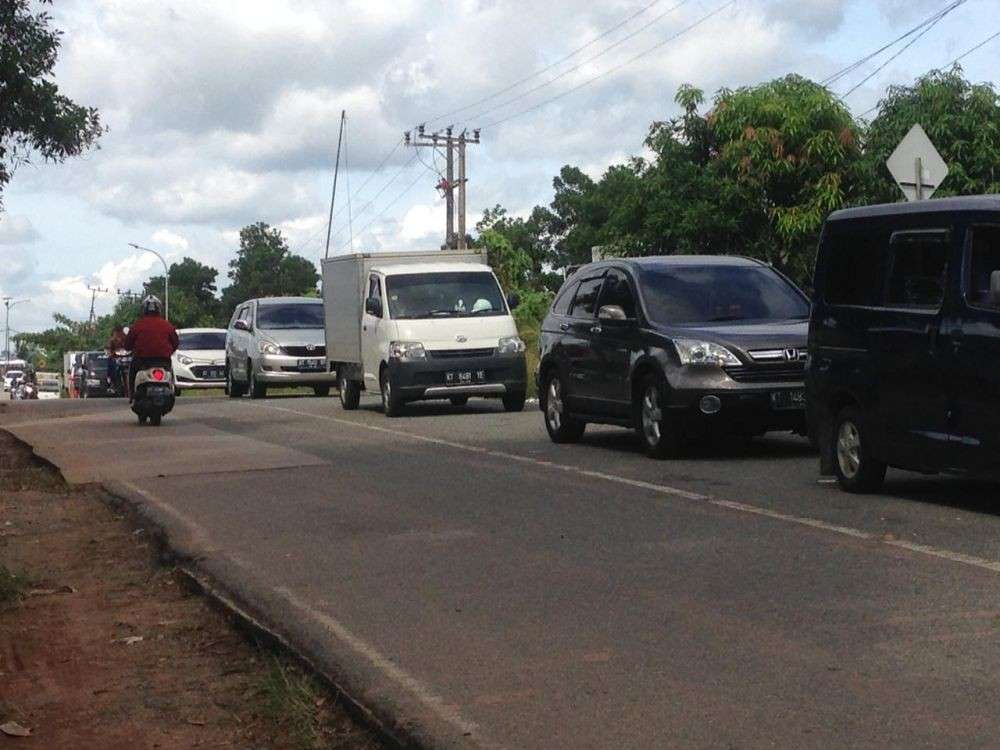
[0,0,1000,330]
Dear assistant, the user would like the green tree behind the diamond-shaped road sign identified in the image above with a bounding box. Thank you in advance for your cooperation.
[864,65,1000,203]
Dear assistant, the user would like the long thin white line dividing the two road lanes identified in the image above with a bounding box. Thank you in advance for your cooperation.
[254,402,1000,573]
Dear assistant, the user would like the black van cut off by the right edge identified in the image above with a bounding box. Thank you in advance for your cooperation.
[807,196,1000,492]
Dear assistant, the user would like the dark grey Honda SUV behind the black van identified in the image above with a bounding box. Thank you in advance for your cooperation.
[538,255,809,457]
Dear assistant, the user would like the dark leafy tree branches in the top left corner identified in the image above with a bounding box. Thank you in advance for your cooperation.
[0,0,104,207]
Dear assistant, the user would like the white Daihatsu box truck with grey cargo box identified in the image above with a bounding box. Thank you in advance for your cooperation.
[323,250,527,416]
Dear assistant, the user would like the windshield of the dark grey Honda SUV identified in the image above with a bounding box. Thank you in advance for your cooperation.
[639,264,809,325]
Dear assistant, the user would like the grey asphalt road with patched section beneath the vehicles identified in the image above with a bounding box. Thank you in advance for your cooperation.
[0,398,1000,748]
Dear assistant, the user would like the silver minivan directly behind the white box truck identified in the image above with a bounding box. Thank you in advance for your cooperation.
[226,297,337,398]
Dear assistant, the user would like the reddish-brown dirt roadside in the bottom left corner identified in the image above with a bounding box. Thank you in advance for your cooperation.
[0,432,382,750]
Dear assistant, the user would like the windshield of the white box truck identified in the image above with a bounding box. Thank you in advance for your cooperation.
[385,271,507,320]
